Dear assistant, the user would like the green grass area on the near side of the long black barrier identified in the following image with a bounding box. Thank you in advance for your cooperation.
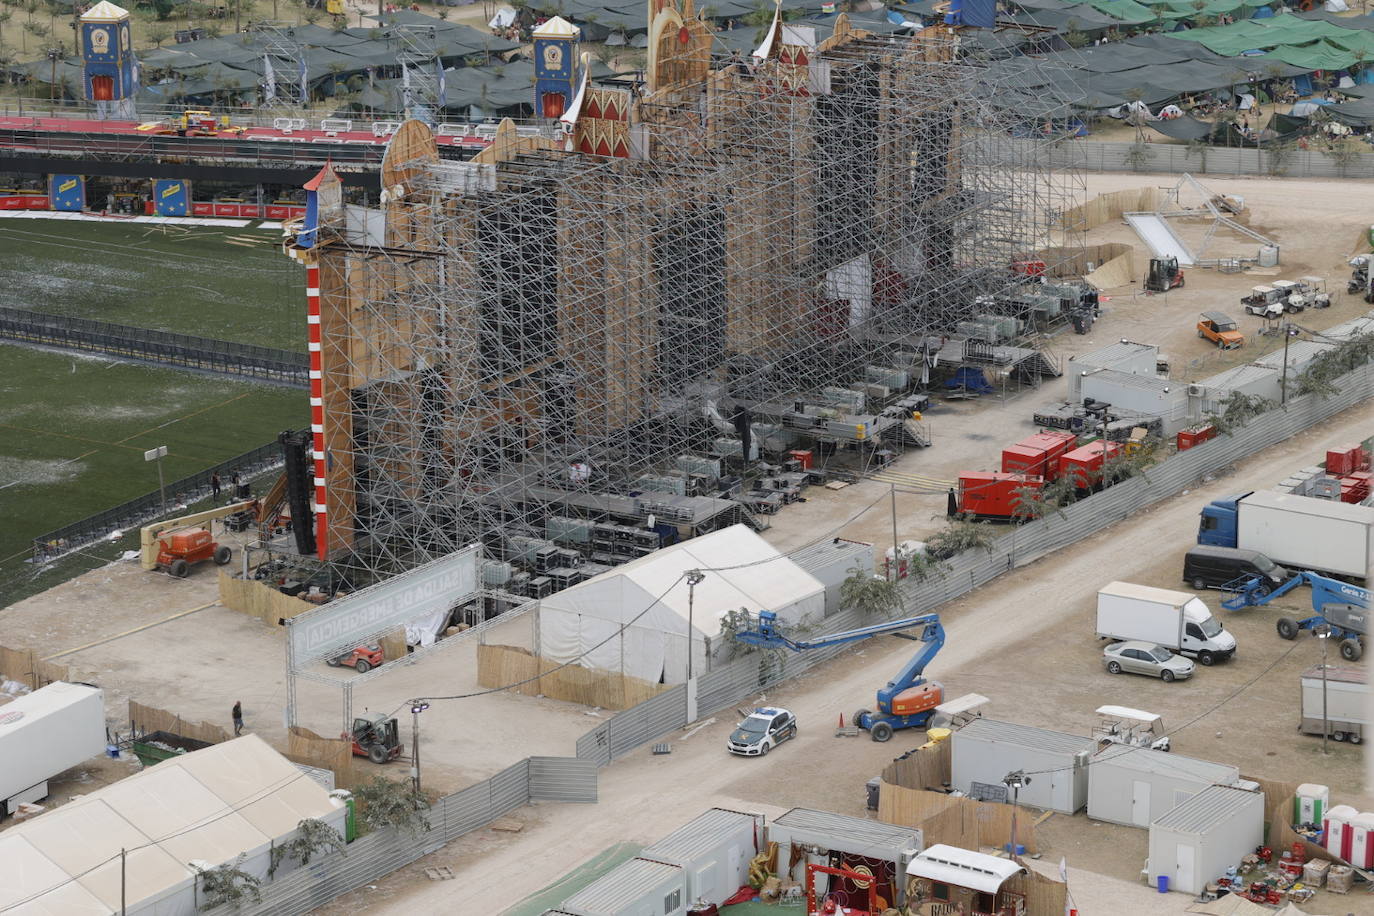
[0,343,309,607]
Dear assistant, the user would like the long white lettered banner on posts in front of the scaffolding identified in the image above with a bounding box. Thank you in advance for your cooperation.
[286,544,481,665]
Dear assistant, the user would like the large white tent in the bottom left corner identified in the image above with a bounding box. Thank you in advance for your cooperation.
[0,735,346,916]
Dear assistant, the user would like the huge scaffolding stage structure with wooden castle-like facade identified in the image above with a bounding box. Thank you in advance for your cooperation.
[294,14,1077,575]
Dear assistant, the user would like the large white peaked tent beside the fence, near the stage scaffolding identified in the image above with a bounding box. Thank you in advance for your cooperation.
[539,525,826,684]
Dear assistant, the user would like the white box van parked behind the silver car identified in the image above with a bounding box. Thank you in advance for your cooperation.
[1098,582,1235,665]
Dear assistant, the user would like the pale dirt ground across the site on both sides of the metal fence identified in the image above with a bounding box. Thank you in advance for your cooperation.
[0,176,1374,913]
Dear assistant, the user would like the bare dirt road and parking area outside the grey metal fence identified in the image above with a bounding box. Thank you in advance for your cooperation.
[323,395,1374,913]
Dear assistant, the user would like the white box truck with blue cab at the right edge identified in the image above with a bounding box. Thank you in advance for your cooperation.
[1198,490,1374,580]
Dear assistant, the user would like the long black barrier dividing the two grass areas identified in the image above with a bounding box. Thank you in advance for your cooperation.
[0,306,311,389]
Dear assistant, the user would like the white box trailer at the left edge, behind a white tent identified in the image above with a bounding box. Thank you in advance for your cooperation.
[0,681,106,817]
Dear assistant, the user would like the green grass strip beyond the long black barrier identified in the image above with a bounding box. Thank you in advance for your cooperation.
[0,220,306,350]
